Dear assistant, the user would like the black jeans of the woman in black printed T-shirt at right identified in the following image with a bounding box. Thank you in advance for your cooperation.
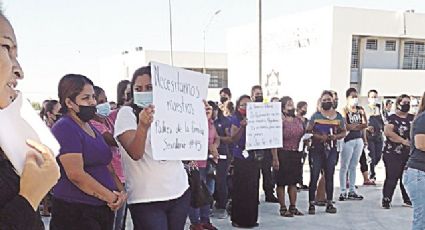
[382,153,410,202]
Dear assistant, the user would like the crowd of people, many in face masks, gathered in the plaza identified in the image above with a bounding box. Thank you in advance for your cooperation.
[0,7,425,230]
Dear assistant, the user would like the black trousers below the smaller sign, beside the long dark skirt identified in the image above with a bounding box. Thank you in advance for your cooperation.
[258,149,275,198]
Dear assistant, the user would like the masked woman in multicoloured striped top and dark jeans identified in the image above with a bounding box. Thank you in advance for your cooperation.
[307,91,346,215]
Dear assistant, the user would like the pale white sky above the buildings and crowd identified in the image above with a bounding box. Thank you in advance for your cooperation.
[0,0,425,101]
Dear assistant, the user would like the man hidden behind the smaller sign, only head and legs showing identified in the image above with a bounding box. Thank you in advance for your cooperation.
[251,85,279,203]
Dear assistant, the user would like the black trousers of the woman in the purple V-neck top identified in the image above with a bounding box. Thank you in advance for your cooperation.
[50,198,114,230]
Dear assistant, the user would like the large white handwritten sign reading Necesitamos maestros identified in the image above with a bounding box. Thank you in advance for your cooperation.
[151,62,209,160]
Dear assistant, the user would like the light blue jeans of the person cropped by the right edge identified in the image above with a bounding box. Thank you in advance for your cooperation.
[403,168,425,230]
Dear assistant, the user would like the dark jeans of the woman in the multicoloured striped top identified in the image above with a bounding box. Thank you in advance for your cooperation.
[308,145,338,202]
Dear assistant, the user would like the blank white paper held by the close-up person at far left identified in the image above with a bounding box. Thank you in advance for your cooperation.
[0,93,60,175]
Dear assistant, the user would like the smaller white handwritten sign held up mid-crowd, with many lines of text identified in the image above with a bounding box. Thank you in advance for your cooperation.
[245,102,283,150]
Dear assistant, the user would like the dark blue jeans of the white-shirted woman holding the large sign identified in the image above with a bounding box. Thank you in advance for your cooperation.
[129,190,190,230]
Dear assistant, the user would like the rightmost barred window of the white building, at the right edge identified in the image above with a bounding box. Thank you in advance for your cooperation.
[403,41,425,69]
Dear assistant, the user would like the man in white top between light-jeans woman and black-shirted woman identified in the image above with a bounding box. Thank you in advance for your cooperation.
[365,89,384,181]
